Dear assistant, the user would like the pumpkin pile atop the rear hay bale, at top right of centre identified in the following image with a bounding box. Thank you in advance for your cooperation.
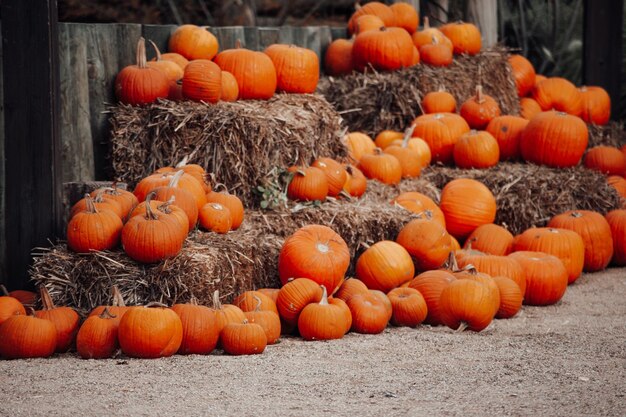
[324,1,482,76]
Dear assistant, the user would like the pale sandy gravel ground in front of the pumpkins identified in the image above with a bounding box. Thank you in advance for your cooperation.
[0,269,626,416]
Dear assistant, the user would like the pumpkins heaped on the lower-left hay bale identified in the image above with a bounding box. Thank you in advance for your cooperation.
[67,164,244,263]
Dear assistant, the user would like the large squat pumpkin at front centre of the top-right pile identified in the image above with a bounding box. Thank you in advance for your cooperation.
[352,27,413,71]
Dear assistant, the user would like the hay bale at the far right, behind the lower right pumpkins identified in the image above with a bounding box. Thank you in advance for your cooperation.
[422,163,621,234]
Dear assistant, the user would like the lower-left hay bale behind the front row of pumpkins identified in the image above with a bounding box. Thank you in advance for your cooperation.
[30,232,277,313]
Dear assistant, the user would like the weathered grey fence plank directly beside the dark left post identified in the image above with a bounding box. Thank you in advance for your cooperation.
[59,23,95,182]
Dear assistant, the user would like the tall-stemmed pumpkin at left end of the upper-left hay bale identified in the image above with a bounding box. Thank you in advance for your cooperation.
[115,38,170,106]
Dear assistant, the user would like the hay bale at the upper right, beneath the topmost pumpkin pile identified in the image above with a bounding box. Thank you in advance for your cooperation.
[318,47,519,135]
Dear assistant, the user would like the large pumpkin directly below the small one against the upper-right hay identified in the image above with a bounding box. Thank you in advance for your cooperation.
[413,113,470,164]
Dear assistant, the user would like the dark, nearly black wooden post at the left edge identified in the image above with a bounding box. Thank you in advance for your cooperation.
[1,0,61,289]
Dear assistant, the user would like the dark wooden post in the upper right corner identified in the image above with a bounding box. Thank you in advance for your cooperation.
[583,0,624,118]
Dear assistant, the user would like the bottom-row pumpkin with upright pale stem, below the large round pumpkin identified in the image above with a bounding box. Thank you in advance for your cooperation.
[298,288,346,340]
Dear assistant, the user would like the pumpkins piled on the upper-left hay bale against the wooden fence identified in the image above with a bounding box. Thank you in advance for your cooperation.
[115,25,319,105]
